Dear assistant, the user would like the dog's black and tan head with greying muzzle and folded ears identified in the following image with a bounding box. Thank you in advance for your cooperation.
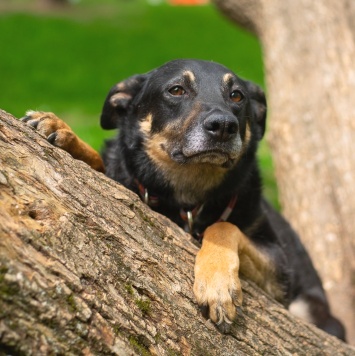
[101,60,266,203]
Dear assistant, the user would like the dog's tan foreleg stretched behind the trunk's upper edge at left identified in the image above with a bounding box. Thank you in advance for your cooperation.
[21,111,105,172]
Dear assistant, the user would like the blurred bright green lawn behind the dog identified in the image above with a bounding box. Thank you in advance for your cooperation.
[0,0,278,207]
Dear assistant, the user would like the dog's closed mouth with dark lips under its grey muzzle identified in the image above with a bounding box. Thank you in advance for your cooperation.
[170,151,236,168]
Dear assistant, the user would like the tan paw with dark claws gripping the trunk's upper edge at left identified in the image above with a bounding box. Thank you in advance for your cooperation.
[21,110,77,153]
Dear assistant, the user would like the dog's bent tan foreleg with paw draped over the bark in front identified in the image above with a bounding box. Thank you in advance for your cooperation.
[194,222,283,333]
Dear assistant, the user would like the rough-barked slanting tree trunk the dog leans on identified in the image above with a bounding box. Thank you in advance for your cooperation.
[0,111,355,355]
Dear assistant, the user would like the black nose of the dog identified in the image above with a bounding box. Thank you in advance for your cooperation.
[203,115,239,141]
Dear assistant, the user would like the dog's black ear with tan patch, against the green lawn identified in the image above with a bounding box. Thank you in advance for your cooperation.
[101,74,146,130]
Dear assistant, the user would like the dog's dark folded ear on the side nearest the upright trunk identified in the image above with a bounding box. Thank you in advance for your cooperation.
[246,81,266,140]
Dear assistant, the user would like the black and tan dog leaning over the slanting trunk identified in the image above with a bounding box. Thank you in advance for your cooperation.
[23,60,344,339]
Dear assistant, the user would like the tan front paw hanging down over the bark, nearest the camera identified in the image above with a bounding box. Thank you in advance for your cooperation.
[194,224,243,333]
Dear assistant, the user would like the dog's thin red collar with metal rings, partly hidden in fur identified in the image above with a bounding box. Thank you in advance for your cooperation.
[136,181,237,239]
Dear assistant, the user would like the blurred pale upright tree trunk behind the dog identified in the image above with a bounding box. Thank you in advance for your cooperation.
[216,0,355,345]
